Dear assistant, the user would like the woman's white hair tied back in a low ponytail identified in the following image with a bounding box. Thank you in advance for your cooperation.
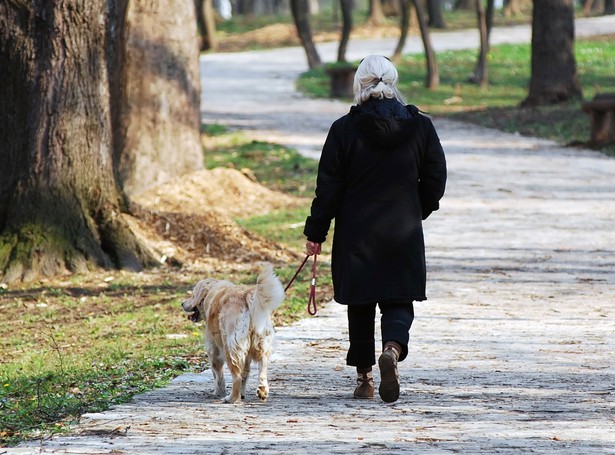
[352,55,405,104]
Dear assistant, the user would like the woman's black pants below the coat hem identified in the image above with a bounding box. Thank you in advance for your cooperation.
[346,302,414,368]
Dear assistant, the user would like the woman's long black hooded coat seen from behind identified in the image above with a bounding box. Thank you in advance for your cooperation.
[304,99,446,304]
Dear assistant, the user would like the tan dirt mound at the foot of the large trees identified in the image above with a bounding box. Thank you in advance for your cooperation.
[127,168,301,263]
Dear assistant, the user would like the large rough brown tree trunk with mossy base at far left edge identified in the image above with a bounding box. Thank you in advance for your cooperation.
[0,0,198,282]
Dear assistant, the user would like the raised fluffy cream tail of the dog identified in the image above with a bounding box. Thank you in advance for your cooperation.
[249,263,284,333]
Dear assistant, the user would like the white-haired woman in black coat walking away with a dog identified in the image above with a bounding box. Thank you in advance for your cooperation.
[304,55,446,403]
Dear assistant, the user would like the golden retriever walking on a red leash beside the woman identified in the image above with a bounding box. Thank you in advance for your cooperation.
[182,264,284,403]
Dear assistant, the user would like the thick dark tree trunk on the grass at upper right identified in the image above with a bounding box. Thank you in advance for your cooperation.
[523,0,582,106]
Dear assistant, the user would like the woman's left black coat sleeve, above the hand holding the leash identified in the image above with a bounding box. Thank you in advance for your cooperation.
[303,120,345,243]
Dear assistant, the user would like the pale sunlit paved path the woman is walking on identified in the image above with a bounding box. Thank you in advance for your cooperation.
[13,16,615,455]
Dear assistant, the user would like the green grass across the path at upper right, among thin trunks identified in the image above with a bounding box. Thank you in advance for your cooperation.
[297,35,615,155]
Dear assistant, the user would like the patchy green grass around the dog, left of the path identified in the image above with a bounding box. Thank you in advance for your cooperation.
[0,127,331,446]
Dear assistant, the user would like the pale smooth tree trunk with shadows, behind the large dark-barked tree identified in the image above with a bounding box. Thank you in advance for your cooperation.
[115,0,201,195]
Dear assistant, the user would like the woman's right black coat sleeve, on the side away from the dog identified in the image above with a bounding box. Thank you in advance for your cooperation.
[419,117,446,220]
